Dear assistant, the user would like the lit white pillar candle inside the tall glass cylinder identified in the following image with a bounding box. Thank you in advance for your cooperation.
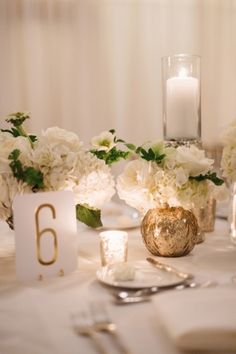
[166,68,199,139]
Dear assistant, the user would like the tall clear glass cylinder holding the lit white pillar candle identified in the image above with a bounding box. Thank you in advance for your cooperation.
[162,54,201,143]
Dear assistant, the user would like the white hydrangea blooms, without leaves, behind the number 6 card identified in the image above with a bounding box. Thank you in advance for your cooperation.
[0,127,115,220]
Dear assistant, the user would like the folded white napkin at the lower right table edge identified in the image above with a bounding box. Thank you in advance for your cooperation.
[154,287,236,352]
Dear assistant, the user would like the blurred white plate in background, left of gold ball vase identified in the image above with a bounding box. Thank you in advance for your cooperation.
[101,202,141,230]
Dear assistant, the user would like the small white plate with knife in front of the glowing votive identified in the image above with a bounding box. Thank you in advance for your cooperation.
[97,261,184,289]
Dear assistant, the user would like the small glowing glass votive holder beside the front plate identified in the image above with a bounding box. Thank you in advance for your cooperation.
[99,230,128,266]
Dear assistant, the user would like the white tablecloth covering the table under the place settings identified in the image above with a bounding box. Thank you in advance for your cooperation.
[0,221,236,354]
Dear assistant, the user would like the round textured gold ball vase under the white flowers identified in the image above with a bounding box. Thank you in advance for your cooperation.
[141,206,198,257]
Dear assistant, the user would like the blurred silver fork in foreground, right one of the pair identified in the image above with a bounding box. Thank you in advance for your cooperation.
[90,301,131,354]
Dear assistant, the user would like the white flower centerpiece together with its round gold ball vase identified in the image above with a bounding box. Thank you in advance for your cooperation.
[117,142,225,257]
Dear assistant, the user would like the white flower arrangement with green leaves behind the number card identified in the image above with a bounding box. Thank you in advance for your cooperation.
[0,112,115,227]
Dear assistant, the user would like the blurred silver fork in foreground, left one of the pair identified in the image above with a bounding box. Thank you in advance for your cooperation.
[71,311,109,354]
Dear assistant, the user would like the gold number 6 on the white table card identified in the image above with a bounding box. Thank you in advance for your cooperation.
[35,204,58,265]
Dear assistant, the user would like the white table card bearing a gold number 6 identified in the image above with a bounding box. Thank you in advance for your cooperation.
[13,191,77,281]
